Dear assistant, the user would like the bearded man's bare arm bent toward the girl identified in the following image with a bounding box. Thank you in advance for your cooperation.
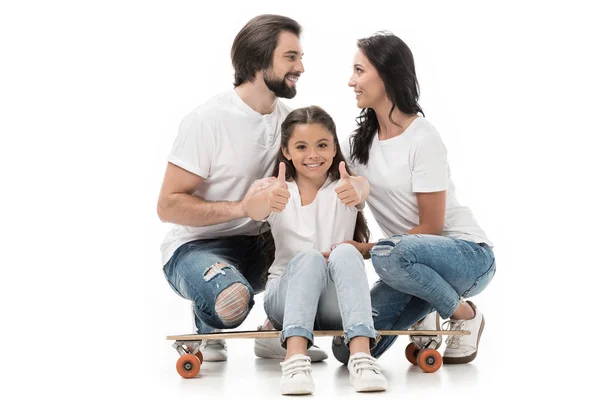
[157,163,273,226]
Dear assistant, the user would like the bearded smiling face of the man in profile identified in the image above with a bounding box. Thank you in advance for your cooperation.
[263,31,304,99]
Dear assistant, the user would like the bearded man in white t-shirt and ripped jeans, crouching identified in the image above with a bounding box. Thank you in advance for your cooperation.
[158,15,327,361]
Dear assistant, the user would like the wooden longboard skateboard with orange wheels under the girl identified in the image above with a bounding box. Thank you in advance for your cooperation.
[167,330,471,379]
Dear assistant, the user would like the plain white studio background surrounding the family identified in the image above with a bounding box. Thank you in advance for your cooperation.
[0,0,600,398]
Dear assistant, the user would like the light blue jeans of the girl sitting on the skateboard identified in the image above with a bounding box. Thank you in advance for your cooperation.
[265,244,378,347]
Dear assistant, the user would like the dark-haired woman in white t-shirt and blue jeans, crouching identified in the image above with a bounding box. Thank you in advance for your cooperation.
[333,33,496,364]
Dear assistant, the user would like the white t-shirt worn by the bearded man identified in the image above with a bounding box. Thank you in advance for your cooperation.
[161,89,291,265]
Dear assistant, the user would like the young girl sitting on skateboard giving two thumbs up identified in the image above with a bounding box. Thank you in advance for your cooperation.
[248,106,387,394]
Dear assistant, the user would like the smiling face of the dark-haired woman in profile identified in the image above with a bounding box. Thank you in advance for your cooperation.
[348,49,387,108]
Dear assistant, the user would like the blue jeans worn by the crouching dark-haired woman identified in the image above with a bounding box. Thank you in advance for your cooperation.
[371,234,496,357]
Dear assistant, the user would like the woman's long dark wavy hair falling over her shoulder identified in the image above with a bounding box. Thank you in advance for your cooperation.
[350,32,425,165]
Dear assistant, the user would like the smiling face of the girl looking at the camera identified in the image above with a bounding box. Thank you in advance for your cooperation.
[281,124,337,184]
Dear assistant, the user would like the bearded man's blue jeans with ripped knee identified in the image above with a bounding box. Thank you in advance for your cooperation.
[163,232,275,333]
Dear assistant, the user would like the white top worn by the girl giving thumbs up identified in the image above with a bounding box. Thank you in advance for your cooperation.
[267,178,358,287]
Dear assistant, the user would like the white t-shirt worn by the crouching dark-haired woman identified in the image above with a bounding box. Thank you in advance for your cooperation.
[341,117,493,246]
